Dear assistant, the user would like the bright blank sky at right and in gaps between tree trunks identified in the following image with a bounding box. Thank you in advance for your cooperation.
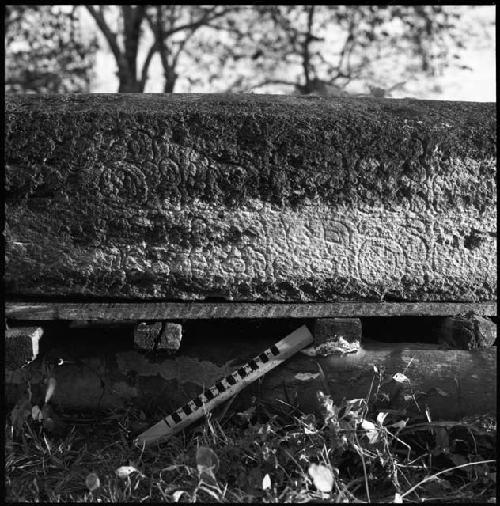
[82,5,496,102]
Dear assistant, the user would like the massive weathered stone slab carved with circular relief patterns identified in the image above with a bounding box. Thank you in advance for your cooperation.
[5,95,497,302]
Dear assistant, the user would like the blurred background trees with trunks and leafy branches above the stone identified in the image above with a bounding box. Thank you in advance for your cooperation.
[5,5,494,96]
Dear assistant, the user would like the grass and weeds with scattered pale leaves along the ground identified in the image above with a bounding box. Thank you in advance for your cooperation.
[5,370,496,503]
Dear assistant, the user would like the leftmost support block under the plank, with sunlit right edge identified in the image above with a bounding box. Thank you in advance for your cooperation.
[4,327,43,369]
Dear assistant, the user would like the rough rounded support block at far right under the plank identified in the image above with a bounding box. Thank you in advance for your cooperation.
[439,312,497,350]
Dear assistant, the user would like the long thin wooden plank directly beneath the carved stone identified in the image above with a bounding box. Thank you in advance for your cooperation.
[5,301,497,323]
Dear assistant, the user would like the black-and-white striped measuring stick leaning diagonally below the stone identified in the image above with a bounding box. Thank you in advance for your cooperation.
[135,325,313,446]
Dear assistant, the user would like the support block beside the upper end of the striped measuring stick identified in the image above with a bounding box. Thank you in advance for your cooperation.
[313,318,362,355]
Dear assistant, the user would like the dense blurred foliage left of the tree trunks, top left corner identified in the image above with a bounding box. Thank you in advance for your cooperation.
[5,5,97,93]
